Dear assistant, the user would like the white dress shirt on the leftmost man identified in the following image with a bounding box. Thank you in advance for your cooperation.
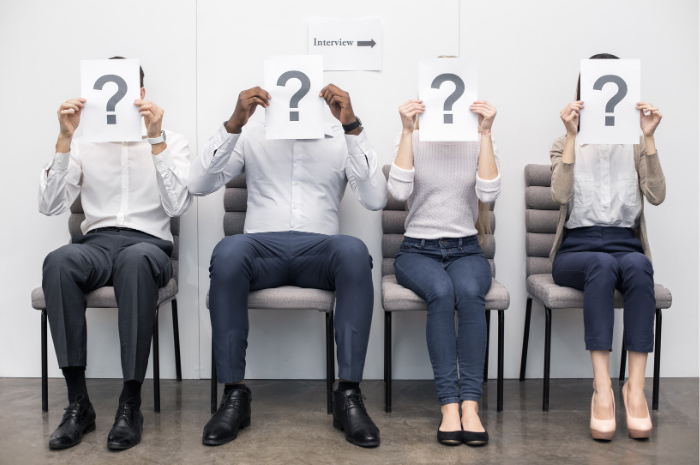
[39,131,192,241]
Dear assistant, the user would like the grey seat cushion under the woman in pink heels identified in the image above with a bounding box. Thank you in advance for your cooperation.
[527,274,671,309]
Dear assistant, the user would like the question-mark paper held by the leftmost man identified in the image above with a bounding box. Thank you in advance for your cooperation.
[80,58,141,142]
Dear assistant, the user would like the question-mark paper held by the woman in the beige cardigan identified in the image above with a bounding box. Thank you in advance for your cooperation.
[578,59,641,144]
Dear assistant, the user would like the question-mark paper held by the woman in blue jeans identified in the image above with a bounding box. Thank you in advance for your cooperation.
[418,58,479,142]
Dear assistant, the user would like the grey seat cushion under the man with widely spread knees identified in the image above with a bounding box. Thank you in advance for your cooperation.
[207,286,335,312]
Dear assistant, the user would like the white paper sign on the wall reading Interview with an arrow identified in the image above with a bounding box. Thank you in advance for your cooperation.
[309,18,383,71]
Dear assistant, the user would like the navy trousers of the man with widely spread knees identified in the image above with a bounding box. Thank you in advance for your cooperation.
[209,231,374,383]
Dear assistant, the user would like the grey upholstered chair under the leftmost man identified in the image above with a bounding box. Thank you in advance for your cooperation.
[32,196,182,412]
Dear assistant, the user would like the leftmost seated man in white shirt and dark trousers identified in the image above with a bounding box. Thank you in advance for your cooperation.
[39,57,192,450]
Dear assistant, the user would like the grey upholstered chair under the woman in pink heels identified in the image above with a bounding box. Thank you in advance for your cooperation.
[520,165,671,412]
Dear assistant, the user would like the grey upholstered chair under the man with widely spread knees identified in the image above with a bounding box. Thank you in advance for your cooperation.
[206,174,335,414]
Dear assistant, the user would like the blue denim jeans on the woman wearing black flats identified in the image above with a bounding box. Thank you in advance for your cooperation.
[394,236,491,405]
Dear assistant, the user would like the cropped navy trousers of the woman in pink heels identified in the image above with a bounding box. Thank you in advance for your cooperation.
[552,226,656,352]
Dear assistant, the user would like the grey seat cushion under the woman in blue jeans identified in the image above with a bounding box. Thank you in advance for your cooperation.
[382,274,510,312]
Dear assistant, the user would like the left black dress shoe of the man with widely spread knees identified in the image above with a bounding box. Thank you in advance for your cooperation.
[202,386,253,446]
